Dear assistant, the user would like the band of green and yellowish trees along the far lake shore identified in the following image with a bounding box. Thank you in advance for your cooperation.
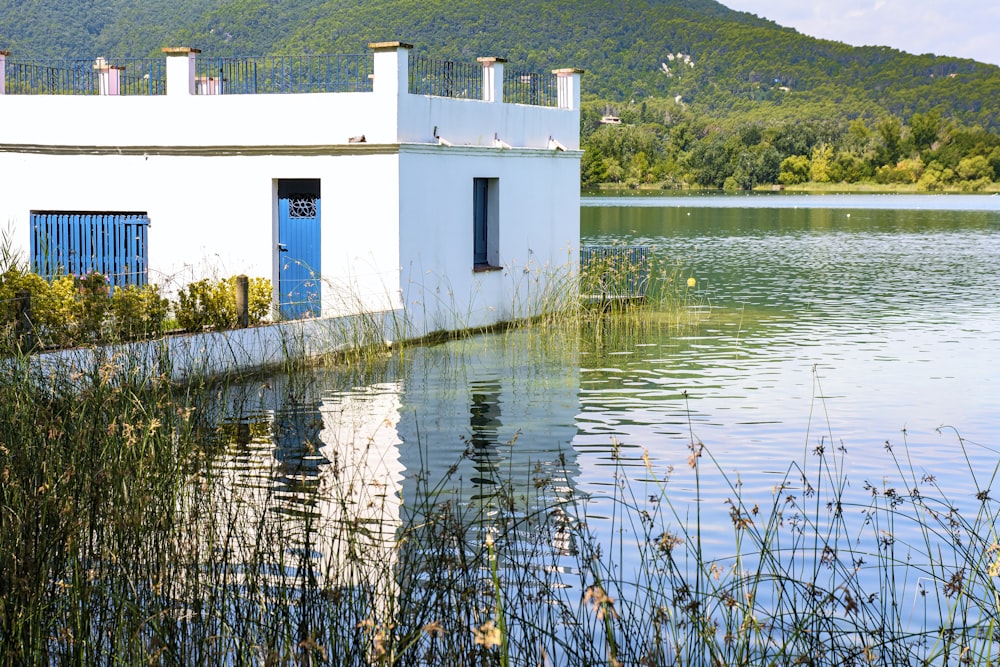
[581,98,1000,192]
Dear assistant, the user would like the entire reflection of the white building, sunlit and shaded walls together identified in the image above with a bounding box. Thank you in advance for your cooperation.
[184,333,579,640]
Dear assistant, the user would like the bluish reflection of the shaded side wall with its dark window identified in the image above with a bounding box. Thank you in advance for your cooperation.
[386,331,579,644]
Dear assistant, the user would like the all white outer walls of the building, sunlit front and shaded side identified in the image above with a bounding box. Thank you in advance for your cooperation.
[0,47,580,335]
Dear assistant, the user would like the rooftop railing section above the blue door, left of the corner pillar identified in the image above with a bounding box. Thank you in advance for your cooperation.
[195,54,373,95]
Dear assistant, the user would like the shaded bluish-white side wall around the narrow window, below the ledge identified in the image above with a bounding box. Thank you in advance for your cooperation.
[400,145,580,333]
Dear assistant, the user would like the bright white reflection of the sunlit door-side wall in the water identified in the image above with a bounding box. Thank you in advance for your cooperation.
[191,378,403,613]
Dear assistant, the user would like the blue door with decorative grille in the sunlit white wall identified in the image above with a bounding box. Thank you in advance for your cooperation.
[278,179,321,319]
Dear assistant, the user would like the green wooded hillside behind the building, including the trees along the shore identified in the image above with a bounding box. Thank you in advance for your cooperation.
[7,0,1000,187]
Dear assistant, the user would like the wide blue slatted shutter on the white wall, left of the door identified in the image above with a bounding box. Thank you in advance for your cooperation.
[31,211,149,287]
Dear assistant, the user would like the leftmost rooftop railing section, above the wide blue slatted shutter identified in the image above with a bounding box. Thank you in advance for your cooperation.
[4,58,167,95]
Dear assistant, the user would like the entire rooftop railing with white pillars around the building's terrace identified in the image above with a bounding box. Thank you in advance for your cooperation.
[0,47,582,109]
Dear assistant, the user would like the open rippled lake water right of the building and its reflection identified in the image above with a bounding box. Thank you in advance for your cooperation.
[577,197,1000,516]
